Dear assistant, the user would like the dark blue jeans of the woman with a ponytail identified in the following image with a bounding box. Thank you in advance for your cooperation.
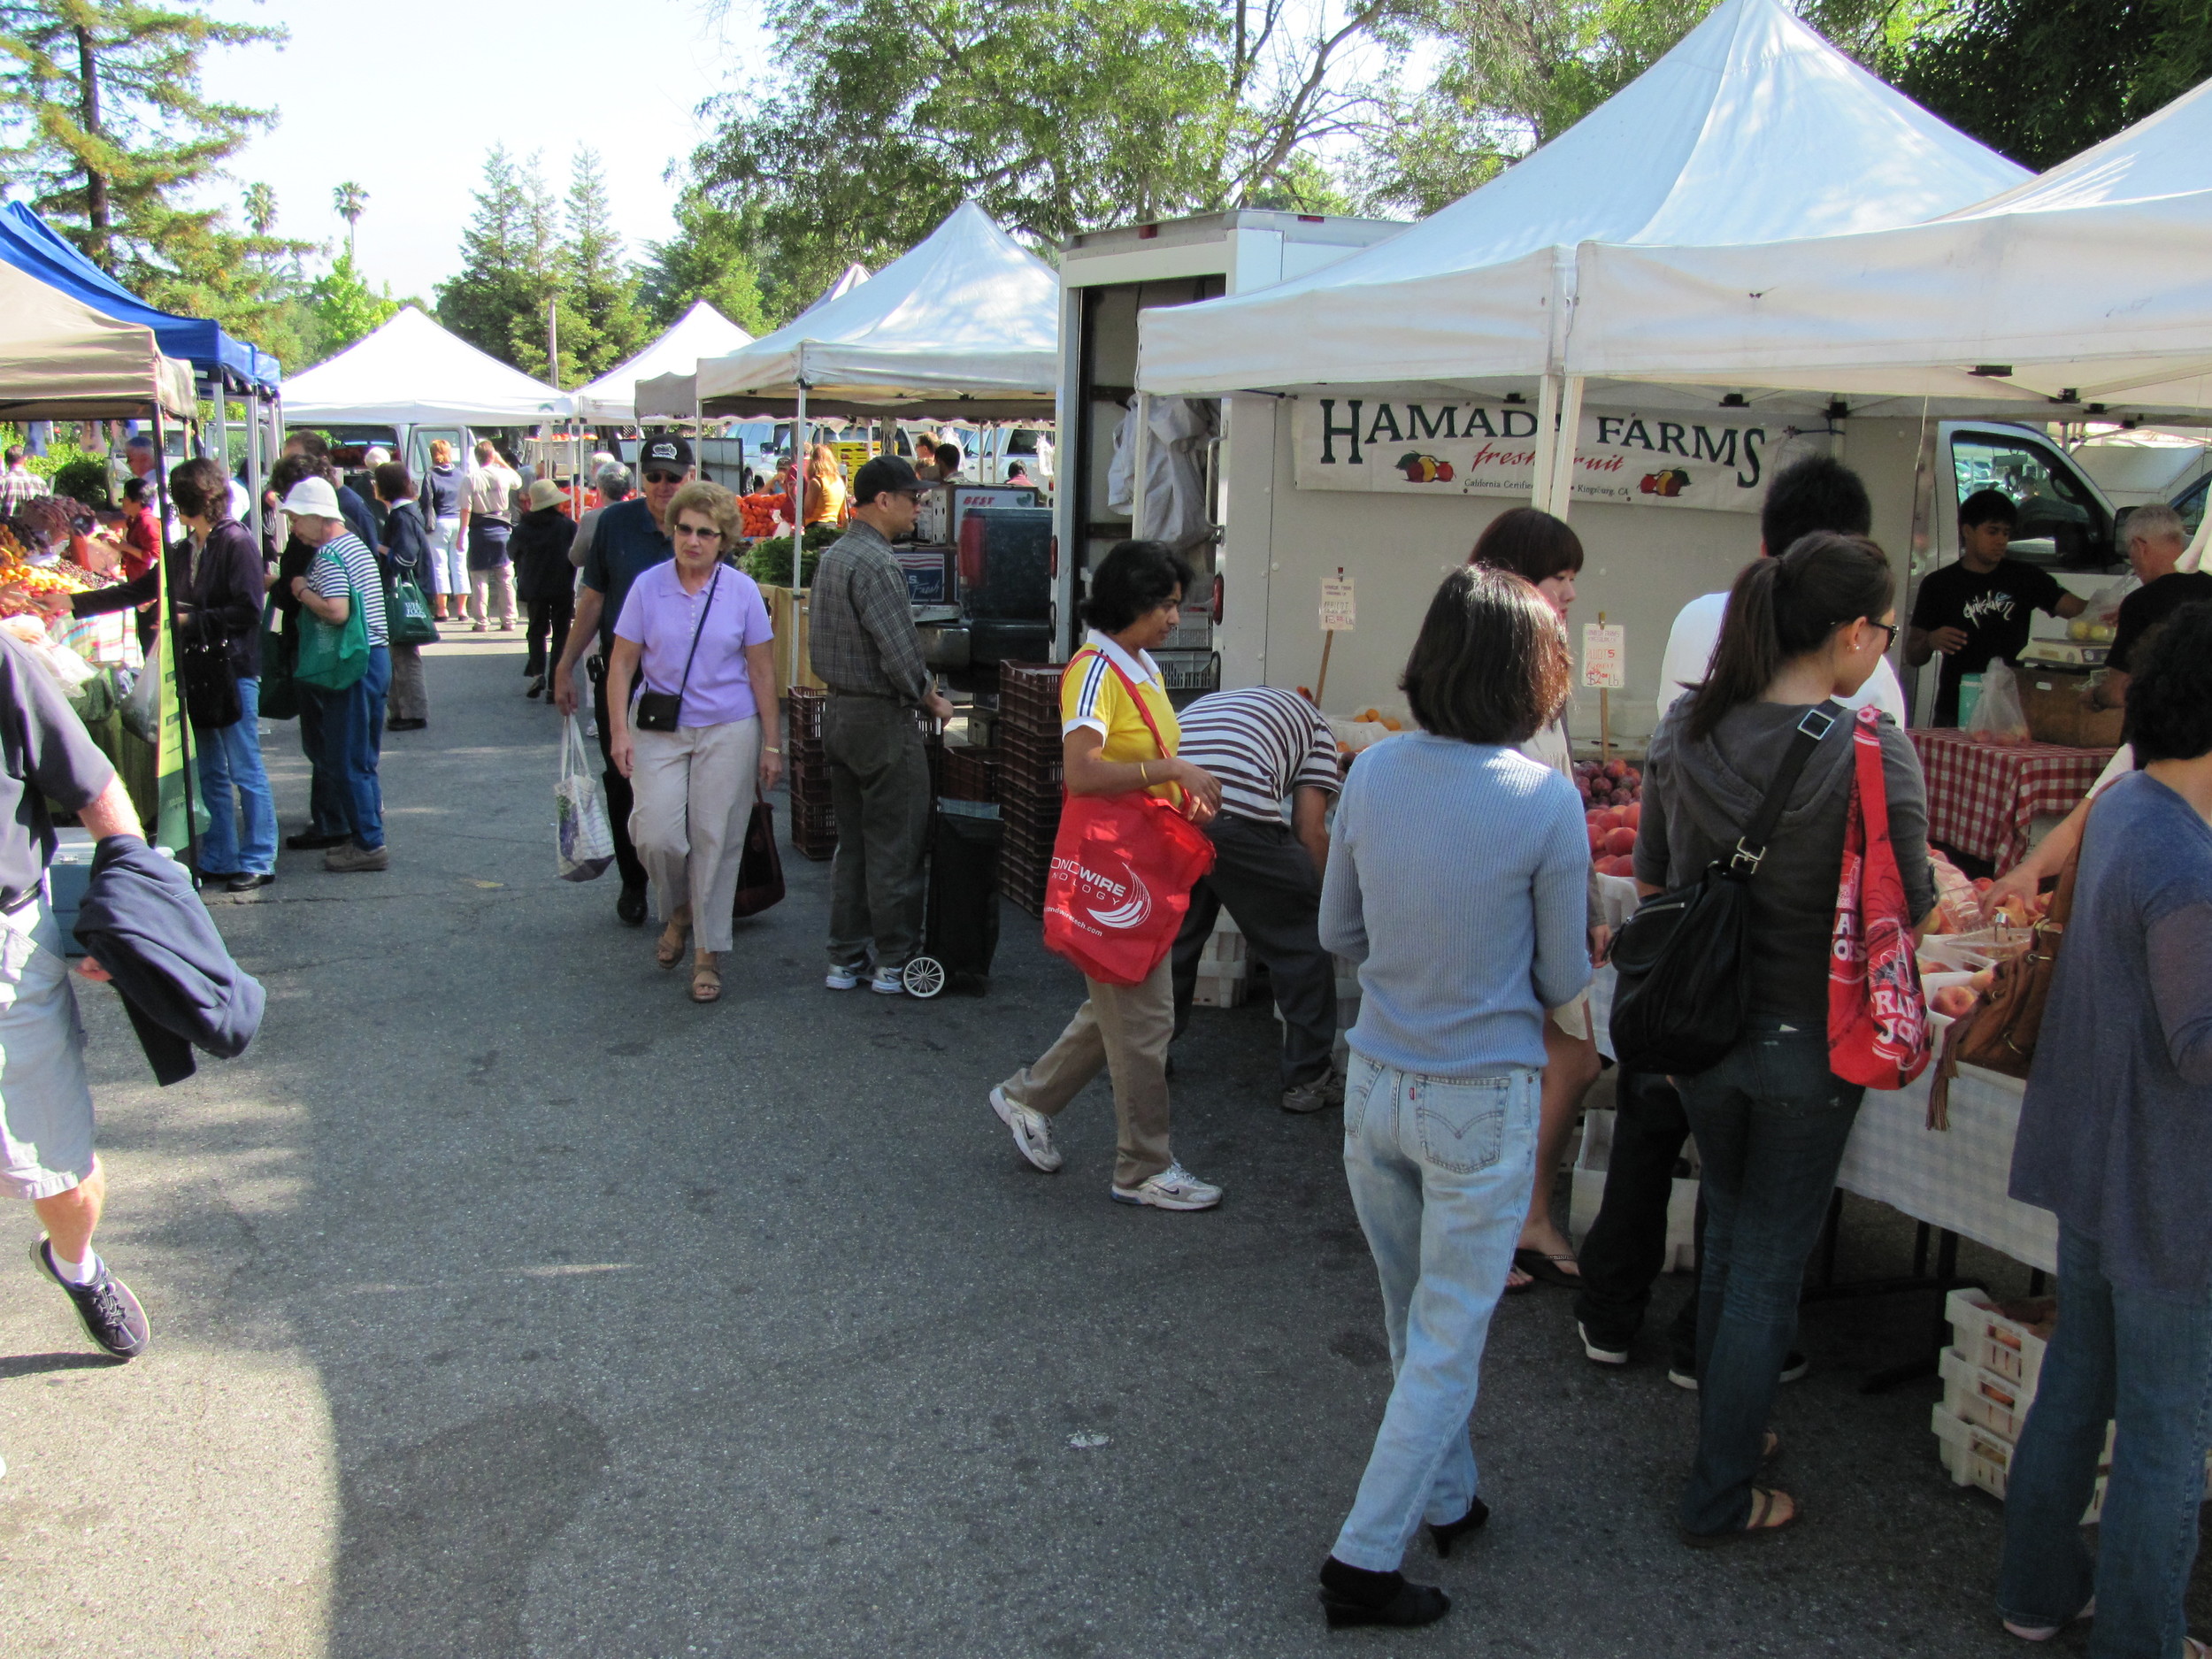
[1675,1016,1867,1533]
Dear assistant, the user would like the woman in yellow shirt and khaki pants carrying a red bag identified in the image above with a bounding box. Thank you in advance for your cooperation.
[991,542,1221,1210]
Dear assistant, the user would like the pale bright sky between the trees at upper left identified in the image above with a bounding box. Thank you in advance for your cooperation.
[202,0,765,301]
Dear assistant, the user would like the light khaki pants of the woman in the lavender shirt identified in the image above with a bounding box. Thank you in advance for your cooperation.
[631,715,761,951]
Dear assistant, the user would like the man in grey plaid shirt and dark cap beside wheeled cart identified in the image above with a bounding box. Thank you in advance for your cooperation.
[808,456,954,998]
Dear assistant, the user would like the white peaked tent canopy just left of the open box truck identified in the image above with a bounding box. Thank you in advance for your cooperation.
[697,202,1060,420]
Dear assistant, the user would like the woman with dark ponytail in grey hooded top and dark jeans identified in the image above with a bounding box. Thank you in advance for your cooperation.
[1637,531,1936,1547]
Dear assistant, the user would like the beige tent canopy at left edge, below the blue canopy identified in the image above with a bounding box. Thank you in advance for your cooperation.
[0,264,193,420]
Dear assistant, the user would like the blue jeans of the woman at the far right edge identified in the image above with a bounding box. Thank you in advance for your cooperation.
[1998,1225,2212,1659]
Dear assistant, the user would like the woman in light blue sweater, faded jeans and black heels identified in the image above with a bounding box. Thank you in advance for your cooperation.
[1321,569,1591,1626]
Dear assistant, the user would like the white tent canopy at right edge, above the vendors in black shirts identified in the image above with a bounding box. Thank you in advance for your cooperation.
[1569,82,2212,420]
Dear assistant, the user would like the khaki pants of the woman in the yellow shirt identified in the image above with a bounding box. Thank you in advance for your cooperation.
[1002,956,1175,1190]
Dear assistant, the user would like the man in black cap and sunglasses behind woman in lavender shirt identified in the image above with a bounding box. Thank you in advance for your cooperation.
[553,438,693,927]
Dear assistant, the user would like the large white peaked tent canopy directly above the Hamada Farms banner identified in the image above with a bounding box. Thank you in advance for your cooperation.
[1137,0,2026,413]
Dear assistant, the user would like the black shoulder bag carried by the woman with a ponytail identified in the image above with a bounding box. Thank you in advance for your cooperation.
[1610,703,1840,1075]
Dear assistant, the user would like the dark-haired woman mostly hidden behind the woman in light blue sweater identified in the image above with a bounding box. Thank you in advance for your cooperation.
[1467,507,1606,1290]
